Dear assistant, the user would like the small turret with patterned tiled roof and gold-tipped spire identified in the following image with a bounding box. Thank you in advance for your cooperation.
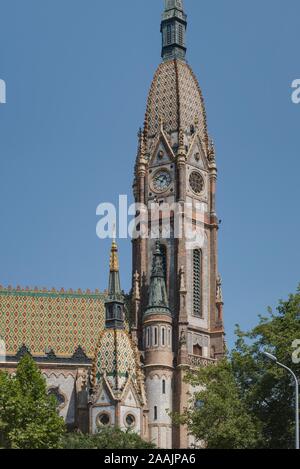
[89,240,148,440]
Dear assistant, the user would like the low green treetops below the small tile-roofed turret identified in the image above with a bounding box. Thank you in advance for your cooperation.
[62,427,155,449]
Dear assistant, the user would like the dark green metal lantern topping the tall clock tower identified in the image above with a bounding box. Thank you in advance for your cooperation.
[161,0,187,61]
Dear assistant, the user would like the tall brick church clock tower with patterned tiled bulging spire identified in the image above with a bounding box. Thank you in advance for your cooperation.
[133,0,224,448]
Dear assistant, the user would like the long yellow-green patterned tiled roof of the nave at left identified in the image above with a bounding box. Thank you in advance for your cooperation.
[0,286,105,359]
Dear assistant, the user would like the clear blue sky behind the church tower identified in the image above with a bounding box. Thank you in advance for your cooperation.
[0,0,300,345]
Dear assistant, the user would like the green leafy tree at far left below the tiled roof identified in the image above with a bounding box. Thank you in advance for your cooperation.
[0,355,65,449]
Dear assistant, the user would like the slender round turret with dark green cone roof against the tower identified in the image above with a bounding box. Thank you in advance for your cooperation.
[143,242,173,449]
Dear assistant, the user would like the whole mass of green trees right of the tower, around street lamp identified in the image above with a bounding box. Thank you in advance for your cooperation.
[180,289,300,449]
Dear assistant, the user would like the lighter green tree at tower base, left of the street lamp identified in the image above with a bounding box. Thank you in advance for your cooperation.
[181,359,259,449]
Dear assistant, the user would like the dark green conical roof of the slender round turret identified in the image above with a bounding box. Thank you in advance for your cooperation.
[145,241,171,315]
